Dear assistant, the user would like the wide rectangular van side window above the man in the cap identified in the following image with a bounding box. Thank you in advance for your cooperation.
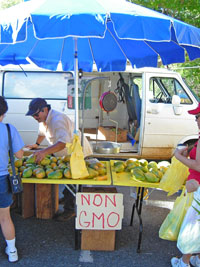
[3,71,72,99]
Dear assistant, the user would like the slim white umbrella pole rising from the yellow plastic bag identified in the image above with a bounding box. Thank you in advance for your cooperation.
[74,38,79,134]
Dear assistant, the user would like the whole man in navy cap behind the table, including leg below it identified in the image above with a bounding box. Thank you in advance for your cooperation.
[26,98,92,221]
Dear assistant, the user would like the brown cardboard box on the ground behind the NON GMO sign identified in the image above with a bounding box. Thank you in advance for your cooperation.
[81,187,117,251]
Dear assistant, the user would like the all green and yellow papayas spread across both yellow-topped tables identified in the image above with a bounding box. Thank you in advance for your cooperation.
[8,155,170,183]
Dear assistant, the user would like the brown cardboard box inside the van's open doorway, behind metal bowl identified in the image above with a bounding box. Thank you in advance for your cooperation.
[98,126,128,142]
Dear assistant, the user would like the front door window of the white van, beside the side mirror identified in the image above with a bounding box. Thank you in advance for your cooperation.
[149,77,192,104]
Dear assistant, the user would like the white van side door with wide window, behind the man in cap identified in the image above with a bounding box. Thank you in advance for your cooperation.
[2,71,74,145]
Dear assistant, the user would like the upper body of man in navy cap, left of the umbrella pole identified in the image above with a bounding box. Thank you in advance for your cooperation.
[26,98,74,162]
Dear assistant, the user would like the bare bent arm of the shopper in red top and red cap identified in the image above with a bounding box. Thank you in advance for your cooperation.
[174,140,200,172]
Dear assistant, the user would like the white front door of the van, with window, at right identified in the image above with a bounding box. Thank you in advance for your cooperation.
[142,73,198,158]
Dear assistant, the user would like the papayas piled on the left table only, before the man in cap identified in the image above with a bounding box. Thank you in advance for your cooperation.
[8,154,107,180]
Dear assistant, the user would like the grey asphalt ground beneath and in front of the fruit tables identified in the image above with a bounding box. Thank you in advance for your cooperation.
[0,187,180,267]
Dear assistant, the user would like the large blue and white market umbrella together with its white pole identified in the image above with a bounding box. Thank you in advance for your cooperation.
[0,0,200,132]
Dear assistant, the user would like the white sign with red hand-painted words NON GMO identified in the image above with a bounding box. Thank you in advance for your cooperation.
[76,193,124,230]
